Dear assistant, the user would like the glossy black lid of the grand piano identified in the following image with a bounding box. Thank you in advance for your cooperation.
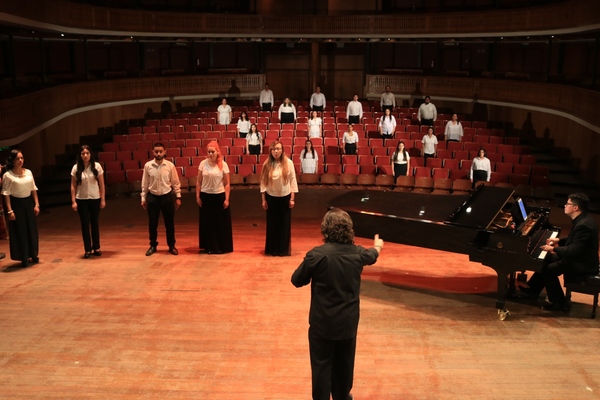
[329,186,514,229]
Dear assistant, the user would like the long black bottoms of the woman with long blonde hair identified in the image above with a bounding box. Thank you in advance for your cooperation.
[265,193,292,256]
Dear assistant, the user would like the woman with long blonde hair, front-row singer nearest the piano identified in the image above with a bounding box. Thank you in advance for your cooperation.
[260,141,298,256]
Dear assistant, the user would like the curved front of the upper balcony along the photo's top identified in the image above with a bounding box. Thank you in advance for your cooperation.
[0,0,600,38]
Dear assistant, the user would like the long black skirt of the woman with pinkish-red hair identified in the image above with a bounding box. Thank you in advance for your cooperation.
[199,192,233,254]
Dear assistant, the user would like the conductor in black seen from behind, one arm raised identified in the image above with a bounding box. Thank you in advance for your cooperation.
[292,208,383,400]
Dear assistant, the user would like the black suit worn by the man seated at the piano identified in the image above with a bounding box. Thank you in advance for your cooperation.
[528,213,598,305]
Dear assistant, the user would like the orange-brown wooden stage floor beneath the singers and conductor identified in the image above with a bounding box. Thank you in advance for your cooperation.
[0,189,600,400]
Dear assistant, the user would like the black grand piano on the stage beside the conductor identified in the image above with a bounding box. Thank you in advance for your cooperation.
[329,185,560,320]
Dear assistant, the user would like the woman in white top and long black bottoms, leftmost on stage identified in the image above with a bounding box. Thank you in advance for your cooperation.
[2,149,40,267]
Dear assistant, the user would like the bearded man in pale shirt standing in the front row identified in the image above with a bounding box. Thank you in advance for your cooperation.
[140,142,181,256]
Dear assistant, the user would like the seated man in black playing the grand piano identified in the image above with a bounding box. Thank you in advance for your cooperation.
[521,193,598,311]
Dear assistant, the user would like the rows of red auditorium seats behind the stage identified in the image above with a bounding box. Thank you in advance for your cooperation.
[98,102,551,197]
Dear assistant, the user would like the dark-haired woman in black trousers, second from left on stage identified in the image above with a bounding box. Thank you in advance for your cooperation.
[71,145,106,258]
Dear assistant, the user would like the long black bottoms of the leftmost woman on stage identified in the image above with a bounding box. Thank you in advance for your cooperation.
[8,196,39,262]
